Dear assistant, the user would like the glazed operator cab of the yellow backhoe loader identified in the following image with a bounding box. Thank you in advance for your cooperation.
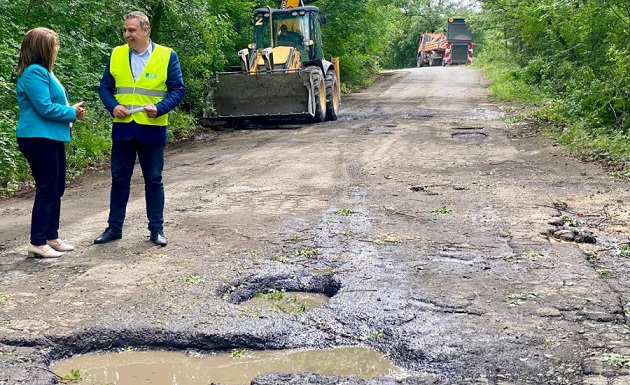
[252,6,324,62]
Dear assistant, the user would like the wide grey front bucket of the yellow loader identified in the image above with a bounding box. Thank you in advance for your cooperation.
[213,72,314,119]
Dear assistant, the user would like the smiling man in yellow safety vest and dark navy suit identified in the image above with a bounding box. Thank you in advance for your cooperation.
[94,12,186,247]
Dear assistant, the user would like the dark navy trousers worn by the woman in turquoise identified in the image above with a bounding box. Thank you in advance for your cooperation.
[17,138,66,246]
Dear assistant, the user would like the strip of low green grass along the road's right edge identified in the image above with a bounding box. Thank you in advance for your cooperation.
[476,49,630,172]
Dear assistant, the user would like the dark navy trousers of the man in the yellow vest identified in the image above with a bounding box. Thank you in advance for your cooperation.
[107,139,165,231]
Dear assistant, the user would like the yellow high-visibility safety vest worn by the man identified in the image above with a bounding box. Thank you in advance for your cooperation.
[109,44,172,126]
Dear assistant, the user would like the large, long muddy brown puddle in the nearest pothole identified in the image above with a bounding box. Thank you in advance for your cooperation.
[51,347,403,385]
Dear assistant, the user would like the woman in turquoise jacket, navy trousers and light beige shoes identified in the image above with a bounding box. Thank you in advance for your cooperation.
[16,28,85,258]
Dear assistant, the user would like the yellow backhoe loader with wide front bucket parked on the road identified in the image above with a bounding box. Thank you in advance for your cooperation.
[202,0,341,124]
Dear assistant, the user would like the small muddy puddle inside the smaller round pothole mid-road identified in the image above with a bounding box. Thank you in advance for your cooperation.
[241,291,329,313]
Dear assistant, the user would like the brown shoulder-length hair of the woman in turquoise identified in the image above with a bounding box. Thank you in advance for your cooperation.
[17,27,59,76]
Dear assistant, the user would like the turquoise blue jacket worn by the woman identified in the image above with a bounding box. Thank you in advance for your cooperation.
[15,64,77,142]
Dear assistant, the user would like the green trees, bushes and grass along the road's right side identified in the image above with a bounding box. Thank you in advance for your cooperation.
[473,0,630,175]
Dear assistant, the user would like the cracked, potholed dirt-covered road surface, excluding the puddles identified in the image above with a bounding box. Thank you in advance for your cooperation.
[0,67,630,385]
